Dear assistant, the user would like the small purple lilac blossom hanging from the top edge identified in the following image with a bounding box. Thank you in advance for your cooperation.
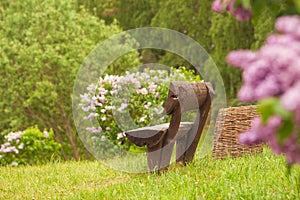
[212,0,252,21]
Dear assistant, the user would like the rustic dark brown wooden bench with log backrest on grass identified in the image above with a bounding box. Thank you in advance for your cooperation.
[125,82,213,172]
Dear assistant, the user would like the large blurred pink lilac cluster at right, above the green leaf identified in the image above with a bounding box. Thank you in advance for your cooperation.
[227,17,300,101]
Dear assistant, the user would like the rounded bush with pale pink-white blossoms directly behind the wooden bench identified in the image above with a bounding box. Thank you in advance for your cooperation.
[80,67,200,154]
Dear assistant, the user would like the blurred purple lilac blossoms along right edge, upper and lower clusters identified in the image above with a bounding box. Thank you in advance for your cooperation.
[227,16,300,164]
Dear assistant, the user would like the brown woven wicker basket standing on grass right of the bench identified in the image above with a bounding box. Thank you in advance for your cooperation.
[212,106,263,158]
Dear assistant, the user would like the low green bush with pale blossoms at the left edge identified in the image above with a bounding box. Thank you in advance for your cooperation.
[0,126,61,166]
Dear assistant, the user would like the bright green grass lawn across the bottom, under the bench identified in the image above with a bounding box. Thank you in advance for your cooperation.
[0,149,300,199]
